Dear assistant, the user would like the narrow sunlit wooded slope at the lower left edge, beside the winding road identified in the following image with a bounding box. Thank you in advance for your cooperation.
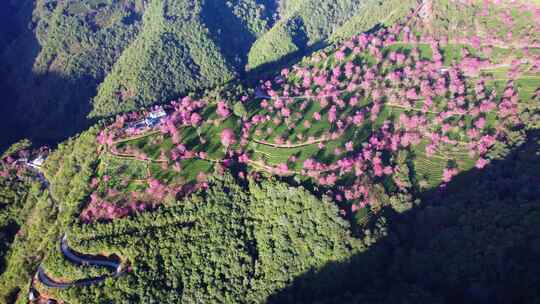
[0,128,97,303]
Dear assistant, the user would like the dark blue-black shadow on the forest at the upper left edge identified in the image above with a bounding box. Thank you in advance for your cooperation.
[0,22,97,150]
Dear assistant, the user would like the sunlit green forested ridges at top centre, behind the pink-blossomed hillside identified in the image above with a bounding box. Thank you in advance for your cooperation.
[92,0,416,116]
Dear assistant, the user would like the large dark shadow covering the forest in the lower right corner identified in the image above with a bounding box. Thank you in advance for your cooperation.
[268,131,540,304]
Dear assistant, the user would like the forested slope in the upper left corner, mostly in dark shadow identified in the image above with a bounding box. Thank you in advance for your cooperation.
[0,0,143,148]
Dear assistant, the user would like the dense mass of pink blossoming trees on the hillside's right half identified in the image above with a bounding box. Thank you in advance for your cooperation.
[242,9,519,213]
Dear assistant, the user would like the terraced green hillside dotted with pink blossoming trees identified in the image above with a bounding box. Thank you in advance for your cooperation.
[90,2,540,221]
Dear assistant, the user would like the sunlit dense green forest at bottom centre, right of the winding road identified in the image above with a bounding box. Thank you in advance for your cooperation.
[36,174,361,303]
